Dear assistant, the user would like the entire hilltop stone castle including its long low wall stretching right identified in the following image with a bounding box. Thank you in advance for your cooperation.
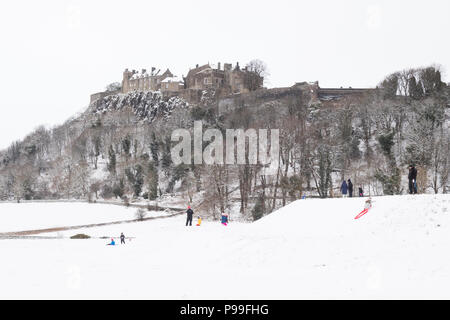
[91,62,376,105]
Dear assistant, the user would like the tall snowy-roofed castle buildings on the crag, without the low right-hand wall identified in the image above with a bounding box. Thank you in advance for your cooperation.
[91,62,264,103]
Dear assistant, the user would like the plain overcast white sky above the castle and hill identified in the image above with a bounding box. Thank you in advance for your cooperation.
[0,0,450,148]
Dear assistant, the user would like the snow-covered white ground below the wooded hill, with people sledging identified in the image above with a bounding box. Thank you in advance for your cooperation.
[0,195,450,299]
